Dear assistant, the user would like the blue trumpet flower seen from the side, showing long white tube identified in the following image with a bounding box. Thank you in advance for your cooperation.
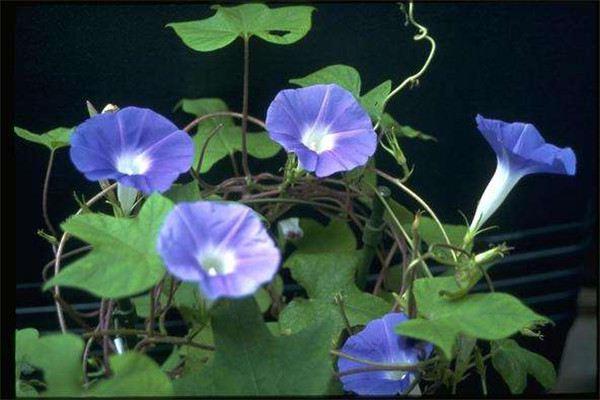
[470,115,577,232]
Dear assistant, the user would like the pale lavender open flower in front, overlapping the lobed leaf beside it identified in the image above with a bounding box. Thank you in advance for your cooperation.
[157,201,281,300]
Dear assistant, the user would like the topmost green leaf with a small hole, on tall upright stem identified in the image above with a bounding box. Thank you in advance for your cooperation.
[167,4,314,51]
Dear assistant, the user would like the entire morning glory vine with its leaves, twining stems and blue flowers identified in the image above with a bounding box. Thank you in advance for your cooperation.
[15,3,576,397]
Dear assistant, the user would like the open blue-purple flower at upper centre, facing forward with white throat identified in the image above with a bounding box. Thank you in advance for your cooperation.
[266,85,377,177]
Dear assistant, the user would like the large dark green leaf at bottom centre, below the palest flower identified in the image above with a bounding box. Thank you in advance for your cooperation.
[174,298,333,397]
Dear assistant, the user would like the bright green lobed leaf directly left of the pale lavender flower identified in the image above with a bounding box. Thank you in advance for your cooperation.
[44,194,173,299]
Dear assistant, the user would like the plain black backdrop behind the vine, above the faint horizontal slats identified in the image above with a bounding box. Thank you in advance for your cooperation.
[12,2,598,282]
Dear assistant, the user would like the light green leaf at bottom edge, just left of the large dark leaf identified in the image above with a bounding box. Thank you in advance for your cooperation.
[86,352,173,397]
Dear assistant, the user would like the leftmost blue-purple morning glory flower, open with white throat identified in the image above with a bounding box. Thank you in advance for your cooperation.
[70,107,194,194]
